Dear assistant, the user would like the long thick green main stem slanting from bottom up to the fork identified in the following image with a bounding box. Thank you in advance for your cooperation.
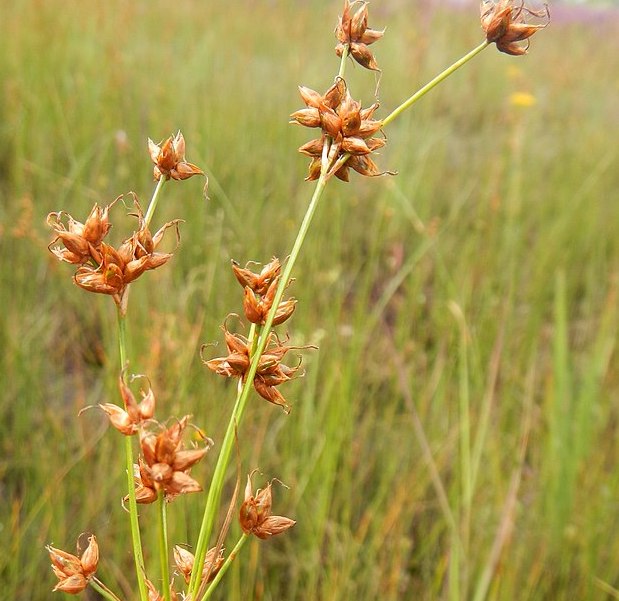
[189,170,328,597]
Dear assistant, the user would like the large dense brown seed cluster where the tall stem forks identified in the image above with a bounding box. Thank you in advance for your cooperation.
[290,78,385,182]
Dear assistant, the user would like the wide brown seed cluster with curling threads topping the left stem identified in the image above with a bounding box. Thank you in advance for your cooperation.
[47,196,179,308]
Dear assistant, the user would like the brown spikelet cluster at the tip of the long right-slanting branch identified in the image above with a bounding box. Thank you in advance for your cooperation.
[480,0,550,56]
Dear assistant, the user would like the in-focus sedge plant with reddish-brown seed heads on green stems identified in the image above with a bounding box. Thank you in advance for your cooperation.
[42,0,549,601]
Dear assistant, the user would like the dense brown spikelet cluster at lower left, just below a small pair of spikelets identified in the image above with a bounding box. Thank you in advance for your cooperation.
[134,415,213,503]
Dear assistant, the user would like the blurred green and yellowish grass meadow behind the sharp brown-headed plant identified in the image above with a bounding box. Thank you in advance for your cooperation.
[0,0,619,601]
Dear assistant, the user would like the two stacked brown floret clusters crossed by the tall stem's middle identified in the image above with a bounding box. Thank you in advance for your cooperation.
[203,258,300,413]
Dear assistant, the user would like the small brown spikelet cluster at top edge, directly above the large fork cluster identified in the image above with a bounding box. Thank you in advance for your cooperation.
[335,0,385,71]
